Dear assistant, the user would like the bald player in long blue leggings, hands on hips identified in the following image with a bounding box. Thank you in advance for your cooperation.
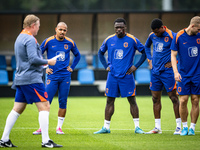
[33,22,80,134]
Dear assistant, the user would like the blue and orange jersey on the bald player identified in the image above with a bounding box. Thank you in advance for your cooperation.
[41,36,80,77]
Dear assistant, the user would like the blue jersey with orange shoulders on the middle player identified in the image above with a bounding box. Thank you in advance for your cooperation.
[99,33,144,78]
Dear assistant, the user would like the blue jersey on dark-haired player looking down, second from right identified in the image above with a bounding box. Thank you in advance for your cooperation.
[145,26,175,75]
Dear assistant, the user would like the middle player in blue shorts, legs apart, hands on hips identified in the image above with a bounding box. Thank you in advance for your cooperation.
[94,18,146,134]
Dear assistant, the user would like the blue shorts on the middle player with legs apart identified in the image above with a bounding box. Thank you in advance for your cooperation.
[105,72,135,97]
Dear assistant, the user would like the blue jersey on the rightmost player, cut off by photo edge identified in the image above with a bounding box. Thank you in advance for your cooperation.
[171,29,200,77]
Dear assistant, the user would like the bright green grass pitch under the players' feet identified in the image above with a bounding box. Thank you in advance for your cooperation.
[0,96,200,150]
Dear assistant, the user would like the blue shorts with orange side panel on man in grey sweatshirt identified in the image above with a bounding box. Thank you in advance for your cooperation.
[15,83,48,104]
